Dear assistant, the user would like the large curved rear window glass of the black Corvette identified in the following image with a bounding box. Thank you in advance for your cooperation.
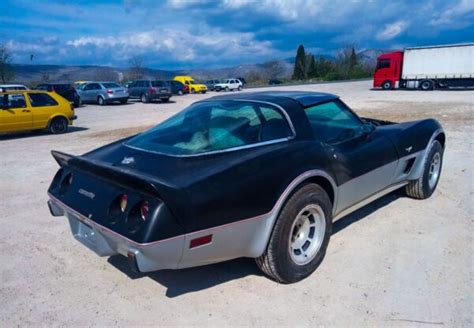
[126,100,292,155]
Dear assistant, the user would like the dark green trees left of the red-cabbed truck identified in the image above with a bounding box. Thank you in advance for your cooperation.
[292,45,373,80]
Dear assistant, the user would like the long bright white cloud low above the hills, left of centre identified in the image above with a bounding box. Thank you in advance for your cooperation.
[66,28,279,62]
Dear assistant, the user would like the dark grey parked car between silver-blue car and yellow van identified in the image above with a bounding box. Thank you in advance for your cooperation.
[128,80,172,103]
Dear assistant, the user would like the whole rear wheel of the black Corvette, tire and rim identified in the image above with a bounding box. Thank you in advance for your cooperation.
[256,184,332,283]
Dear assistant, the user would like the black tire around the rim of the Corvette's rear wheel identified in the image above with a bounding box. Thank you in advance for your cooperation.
[256,184,332,284]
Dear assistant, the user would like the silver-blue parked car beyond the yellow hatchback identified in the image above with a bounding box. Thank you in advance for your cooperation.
[77,82,129,106]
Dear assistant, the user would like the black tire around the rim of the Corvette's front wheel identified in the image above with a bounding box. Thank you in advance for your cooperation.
[405,140,444,199]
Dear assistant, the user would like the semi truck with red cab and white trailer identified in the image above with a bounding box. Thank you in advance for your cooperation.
[373,43,474,90]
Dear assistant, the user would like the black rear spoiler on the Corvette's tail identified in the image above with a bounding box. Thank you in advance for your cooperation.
[51,150,159,197]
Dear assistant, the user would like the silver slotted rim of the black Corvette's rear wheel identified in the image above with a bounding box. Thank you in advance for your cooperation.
[289,204,326,265]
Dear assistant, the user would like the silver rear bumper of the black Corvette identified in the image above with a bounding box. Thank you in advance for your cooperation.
[48,199,185,272]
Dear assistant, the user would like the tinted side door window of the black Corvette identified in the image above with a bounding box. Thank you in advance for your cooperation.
[305,100,363,144]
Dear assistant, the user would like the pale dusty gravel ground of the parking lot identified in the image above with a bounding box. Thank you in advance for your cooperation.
[0,81,474,327]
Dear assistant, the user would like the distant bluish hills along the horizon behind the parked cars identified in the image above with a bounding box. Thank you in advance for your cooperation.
[13,49,386,83]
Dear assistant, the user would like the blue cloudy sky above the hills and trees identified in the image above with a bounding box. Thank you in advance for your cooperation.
[0,0,474,69]
